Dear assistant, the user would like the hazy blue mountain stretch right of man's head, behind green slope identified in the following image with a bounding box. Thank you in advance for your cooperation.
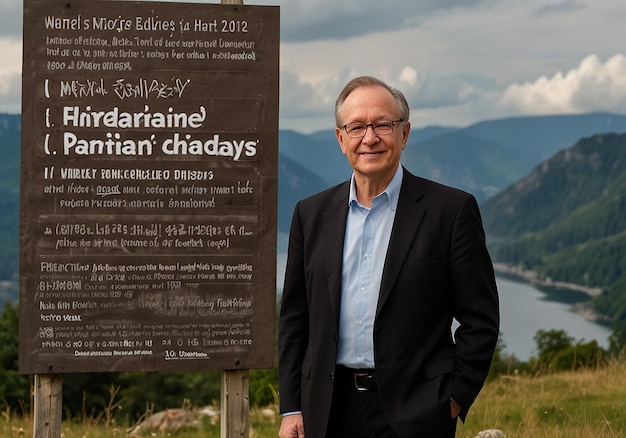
[403,113,626,202]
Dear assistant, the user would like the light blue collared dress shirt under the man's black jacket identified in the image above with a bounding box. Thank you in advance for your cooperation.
[337,166,402,368]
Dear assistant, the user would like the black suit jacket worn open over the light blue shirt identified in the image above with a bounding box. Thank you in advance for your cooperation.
[279,169,499,438]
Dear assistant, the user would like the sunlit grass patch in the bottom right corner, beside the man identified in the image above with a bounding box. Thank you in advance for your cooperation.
[457,360,626,438]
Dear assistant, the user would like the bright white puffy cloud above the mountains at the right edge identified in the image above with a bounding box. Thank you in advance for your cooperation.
[500,54,626,114]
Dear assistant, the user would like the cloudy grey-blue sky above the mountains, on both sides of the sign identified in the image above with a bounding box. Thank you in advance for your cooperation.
[0,0,626,133]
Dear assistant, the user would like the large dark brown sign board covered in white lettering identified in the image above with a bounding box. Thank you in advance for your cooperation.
[19,0,279,374]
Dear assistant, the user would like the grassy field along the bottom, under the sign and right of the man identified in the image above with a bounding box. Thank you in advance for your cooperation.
[0,360,626,438]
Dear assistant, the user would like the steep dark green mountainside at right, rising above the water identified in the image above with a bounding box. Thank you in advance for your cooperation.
[482,134,626,340]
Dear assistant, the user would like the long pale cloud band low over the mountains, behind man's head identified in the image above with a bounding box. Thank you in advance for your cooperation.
[281,50,626,132]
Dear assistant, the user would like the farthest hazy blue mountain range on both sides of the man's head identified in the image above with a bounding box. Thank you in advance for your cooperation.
[290,113,626,202]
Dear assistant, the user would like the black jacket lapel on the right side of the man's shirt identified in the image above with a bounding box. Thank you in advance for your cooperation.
[376,170,426,315]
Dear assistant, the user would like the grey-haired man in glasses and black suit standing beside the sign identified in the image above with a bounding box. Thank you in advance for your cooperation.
[278,77,499,438]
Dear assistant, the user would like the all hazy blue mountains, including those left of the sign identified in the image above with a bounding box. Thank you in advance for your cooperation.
[0,113,626,301]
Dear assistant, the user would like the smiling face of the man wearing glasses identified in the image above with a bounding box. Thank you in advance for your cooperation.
[335,87,410,183]
